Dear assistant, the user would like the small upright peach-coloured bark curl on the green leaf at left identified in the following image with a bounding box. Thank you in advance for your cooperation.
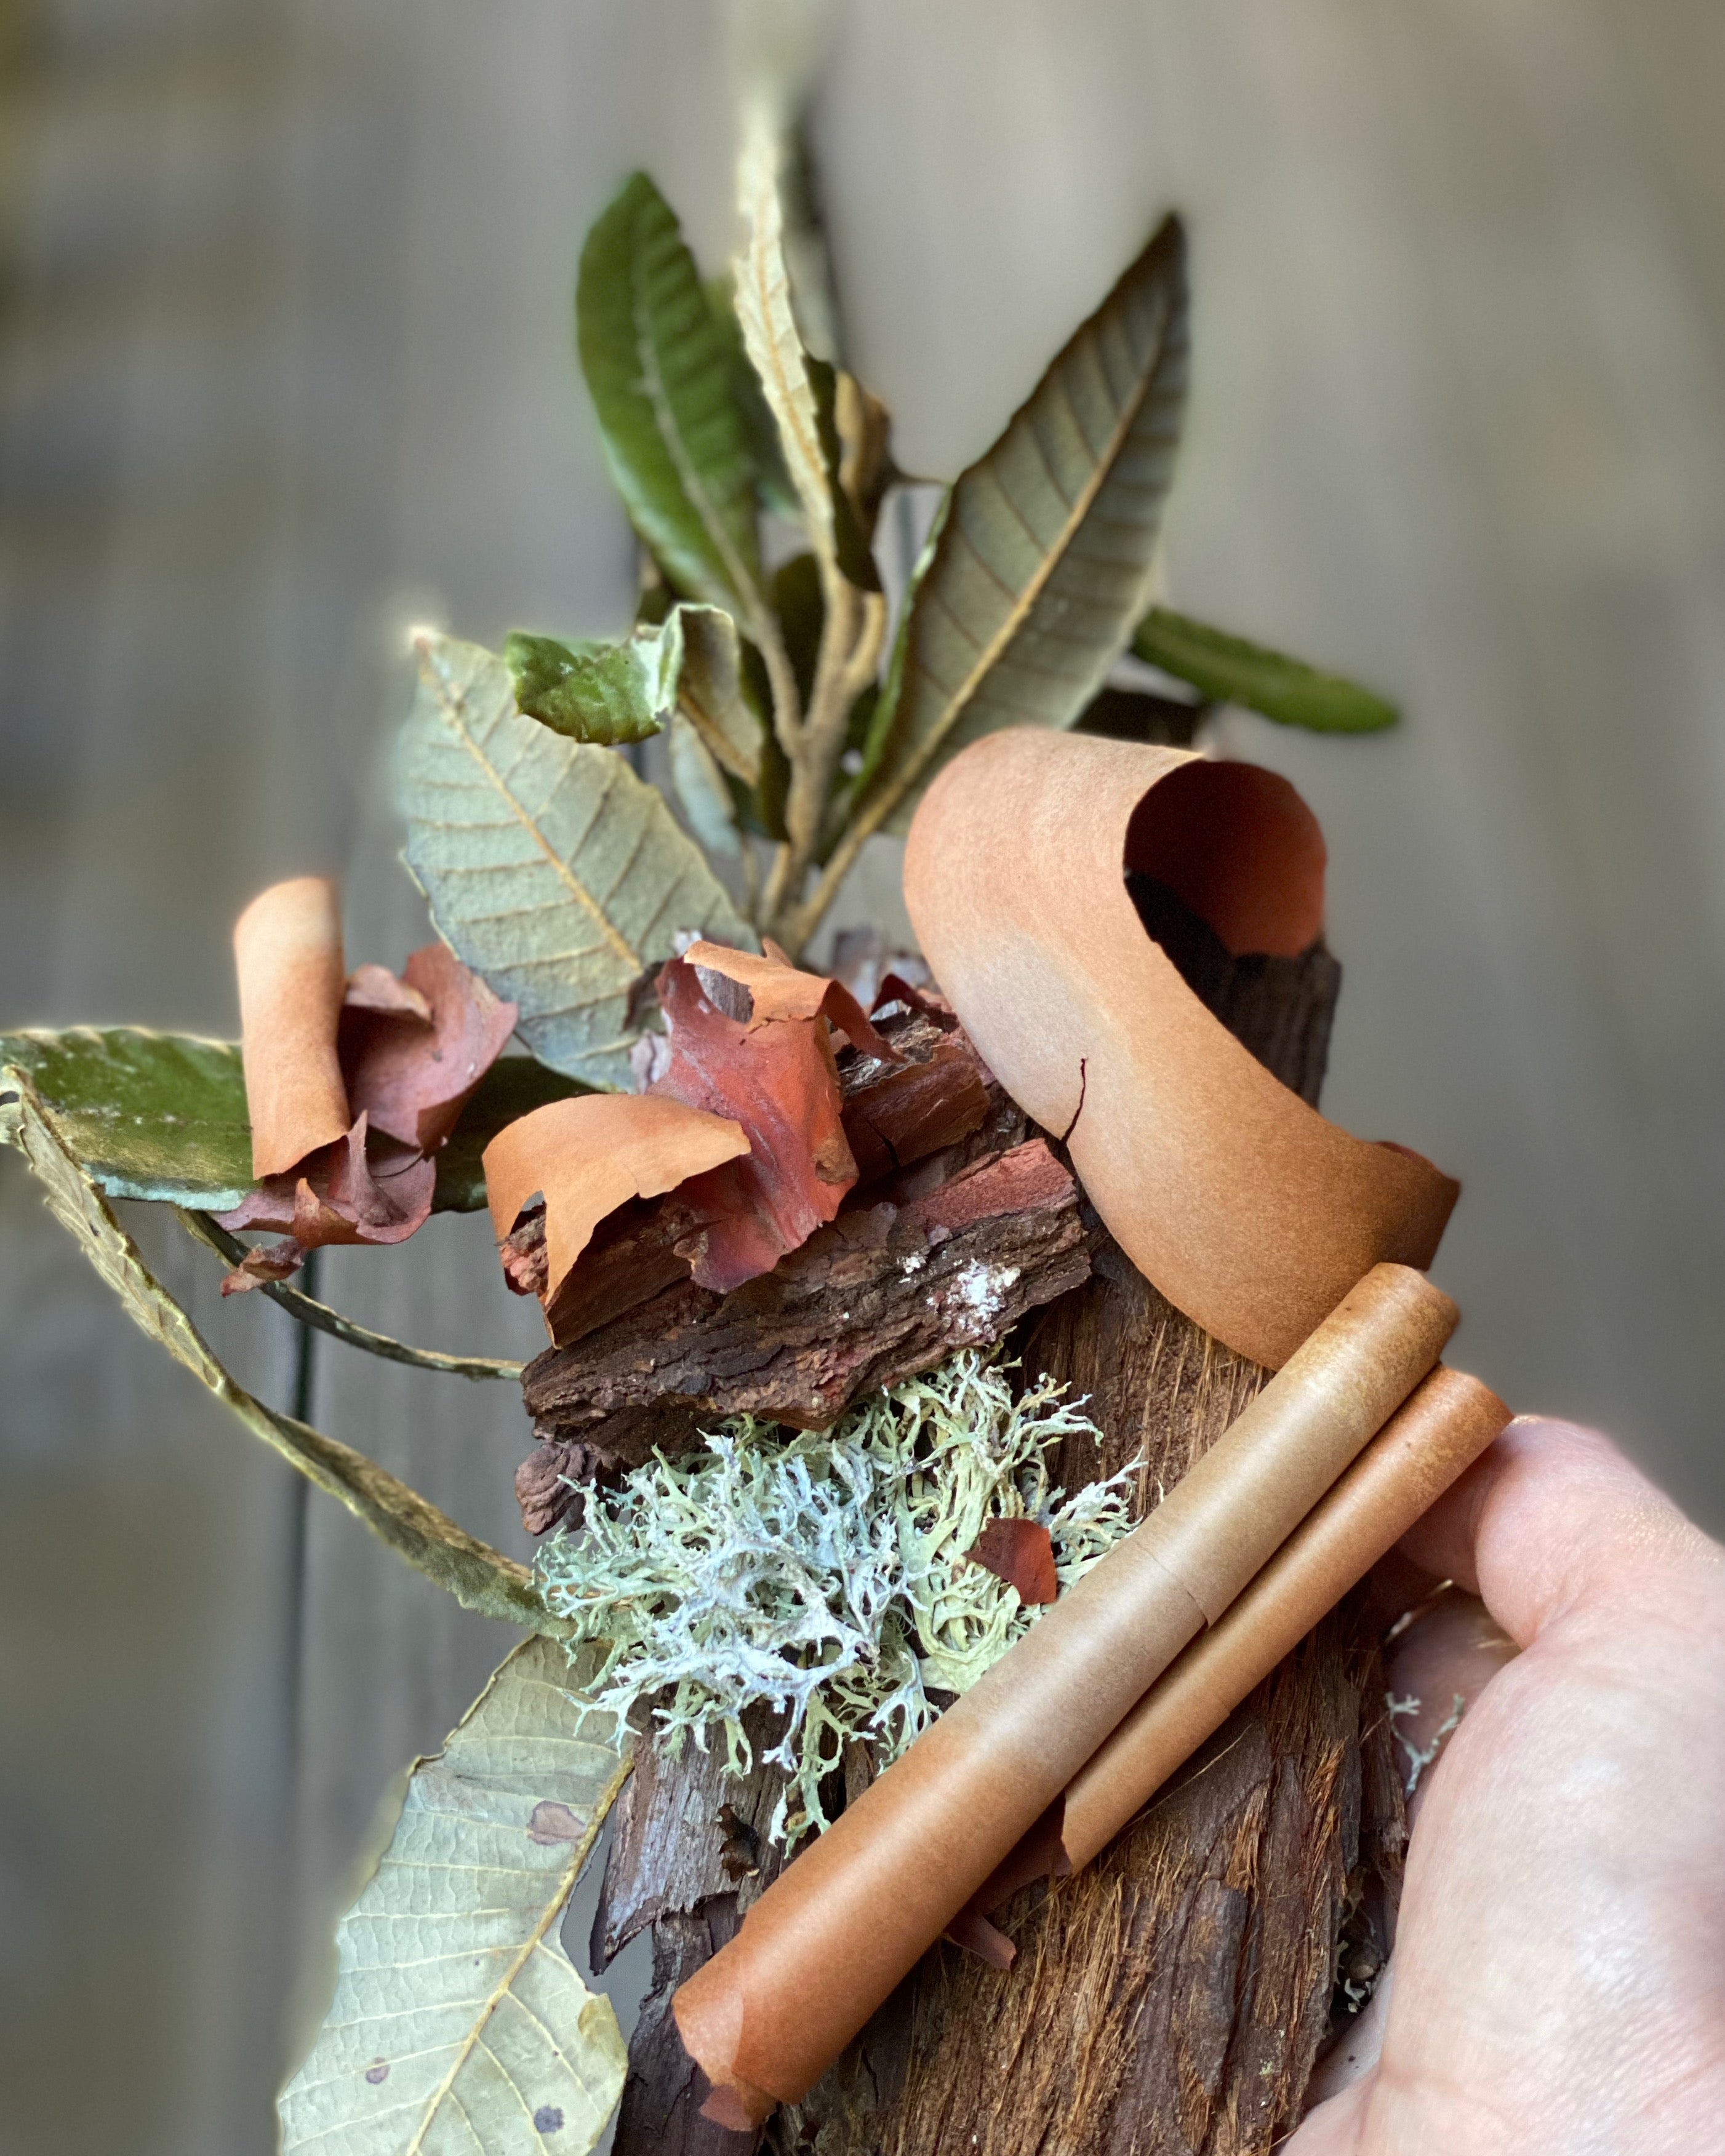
[233,876,351,1180]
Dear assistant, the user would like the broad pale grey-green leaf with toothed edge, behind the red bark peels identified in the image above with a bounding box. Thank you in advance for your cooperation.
[401,632,753,1089]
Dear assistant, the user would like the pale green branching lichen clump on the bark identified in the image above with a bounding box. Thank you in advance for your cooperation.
[537,1350,1136,1841]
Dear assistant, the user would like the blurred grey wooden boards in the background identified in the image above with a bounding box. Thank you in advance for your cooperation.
[0,0,1725,2156]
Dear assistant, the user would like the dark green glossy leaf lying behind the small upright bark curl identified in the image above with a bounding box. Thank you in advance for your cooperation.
[0,1026,580,1212]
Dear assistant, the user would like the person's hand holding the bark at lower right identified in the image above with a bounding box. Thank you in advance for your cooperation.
[1287,1419,1725,2156]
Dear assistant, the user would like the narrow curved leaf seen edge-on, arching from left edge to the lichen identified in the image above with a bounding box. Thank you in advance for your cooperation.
[0,1061,543,1630]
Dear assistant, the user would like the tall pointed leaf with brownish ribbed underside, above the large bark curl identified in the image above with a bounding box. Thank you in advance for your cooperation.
[860,218,1186,824]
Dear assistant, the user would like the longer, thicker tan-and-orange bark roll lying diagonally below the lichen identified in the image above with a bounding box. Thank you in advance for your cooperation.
[675,1266,1458,2126]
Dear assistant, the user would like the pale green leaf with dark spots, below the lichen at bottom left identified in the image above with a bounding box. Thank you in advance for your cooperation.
[280,1641,630,2156]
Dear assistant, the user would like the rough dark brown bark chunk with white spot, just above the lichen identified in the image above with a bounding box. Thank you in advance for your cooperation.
[522,1138,1095,1459]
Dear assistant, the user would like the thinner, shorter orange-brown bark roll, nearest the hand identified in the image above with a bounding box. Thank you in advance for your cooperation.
[1065,1367,1510,1871]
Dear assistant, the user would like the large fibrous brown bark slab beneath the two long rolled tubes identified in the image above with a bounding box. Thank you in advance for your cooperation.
[767,918,1401,2156]
